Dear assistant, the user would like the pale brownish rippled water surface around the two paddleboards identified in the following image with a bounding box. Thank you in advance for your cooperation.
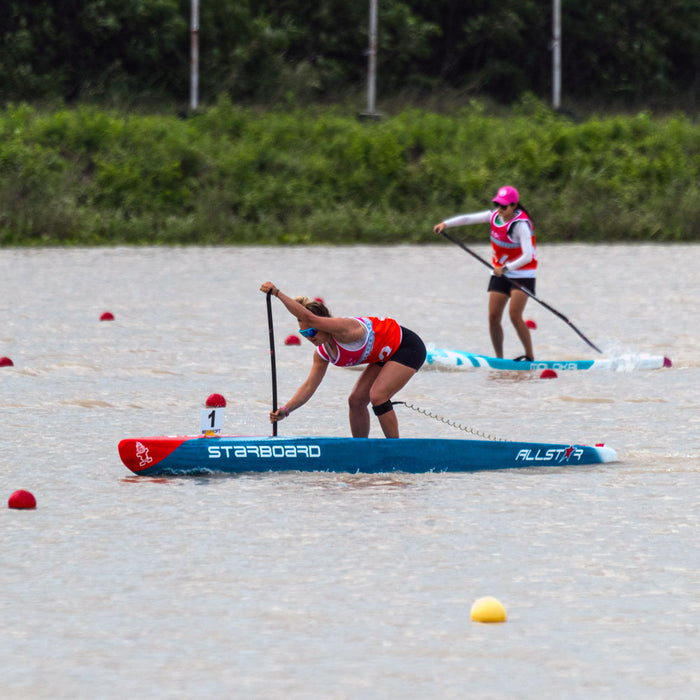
[0,245,700,699]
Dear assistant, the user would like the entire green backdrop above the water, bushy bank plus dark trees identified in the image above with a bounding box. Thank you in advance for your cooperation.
[0,0,700,246]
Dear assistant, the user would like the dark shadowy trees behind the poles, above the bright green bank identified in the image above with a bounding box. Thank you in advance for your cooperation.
[0,0,700,110]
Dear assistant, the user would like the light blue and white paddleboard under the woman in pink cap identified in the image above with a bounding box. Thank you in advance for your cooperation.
[426,348,672,372]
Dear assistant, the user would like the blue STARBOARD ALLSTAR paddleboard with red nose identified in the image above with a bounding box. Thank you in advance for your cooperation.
[119,436,617,476]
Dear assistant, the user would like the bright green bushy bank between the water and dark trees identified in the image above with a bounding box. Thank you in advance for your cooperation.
[0,97,700,246]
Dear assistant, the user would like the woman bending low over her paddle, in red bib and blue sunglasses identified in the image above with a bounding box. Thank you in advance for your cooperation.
[260,282,425,438]
